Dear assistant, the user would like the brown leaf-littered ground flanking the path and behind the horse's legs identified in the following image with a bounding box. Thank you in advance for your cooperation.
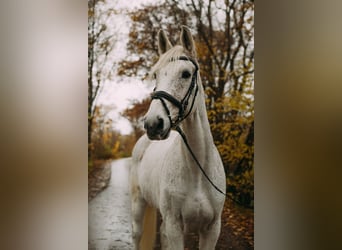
[88,162,254,250]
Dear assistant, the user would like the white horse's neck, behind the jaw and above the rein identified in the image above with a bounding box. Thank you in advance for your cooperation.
[181,92,213,165]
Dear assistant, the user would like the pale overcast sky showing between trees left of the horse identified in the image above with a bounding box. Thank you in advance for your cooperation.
[96,0,157,134]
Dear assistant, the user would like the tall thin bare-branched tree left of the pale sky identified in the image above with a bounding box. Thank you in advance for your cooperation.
[88,0,116,159]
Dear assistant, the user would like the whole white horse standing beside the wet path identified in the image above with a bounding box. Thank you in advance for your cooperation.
[130,26,226,250]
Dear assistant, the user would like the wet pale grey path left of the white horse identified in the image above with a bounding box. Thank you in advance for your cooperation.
[88,158,132,250]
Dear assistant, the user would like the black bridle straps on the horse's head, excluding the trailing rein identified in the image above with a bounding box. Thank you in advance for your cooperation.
[151,56,198,128]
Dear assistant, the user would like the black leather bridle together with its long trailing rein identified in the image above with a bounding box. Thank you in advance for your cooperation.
[151,56,253,208]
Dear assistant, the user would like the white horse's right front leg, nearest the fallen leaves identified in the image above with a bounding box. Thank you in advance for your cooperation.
[199,217,221,250]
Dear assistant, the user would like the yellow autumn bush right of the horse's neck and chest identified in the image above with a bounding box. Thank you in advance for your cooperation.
[208,93,254,206]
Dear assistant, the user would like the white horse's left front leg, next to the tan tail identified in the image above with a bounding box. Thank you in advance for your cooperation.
[161,215,184,250]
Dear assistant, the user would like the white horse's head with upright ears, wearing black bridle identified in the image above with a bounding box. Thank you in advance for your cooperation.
[144,26,198,140]
